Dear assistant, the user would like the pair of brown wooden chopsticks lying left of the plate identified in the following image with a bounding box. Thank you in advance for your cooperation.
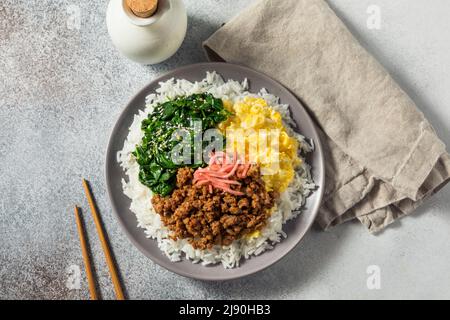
[75,179,125,300]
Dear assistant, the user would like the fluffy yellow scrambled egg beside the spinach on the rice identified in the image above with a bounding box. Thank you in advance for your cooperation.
[219,97,301,193]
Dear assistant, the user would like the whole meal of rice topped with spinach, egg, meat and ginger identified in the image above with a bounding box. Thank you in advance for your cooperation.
[117,72,316,268]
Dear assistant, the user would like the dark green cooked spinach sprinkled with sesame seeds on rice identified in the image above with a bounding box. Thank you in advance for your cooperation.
[133,93,231,196]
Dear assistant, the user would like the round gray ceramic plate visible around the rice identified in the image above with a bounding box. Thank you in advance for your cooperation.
[106,63,325,280]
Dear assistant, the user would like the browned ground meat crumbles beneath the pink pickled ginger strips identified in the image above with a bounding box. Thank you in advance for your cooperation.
[152,166,274,250]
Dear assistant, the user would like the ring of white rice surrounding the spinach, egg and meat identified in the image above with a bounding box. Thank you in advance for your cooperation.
[117,72,316,268]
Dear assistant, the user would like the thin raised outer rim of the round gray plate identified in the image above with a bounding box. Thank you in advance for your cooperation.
[104,62,325,281]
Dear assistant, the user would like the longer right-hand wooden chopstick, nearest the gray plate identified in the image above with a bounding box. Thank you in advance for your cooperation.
[83,179,125,300]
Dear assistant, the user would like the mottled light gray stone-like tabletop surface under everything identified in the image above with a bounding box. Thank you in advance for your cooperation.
[0,0,450,299]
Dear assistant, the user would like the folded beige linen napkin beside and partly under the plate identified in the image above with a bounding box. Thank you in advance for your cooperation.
[204,0,450,232]
